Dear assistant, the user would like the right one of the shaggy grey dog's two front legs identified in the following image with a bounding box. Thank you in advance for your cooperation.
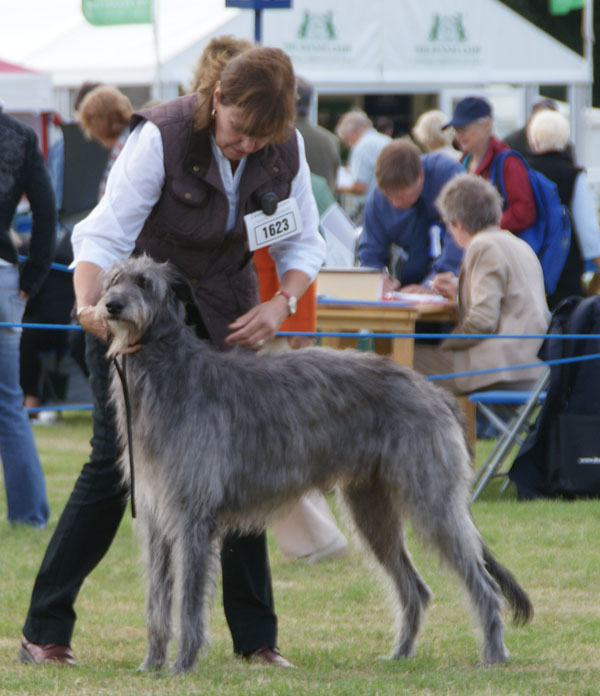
[171,519,214,673]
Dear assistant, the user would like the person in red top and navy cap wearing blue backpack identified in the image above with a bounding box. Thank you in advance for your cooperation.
[444,97,536,233]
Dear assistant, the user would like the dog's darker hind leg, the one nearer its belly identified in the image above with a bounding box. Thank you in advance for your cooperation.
[342,480,431,658]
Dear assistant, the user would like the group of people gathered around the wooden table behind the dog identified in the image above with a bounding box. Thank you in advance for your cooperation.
[357,96,600,394]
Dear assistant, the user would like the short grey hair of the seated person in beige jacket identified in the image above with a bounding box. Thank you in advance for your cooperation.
[435,174,503,234]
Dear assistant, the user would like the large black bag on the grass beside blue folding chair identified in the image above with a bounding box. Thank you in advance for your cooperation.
[509,296,600,500]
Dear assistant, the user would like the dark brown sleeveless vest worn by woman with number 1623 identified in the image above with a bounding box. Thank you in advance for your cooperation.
[131,95,299,348]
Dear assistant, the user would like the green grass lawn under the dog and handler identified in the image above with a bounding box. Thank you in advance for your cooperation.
[0,415,600,696]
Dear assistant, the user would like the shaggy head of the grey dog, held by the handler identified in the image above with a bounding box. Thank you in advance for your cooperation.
[96,255,193,357]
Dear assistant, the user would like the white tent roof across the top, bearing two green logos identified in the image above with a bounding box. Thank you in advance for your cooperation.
[0,0,591,93]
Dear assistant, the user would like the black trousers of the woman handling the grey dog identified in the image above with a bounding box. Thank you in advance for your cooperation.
[23,335,277,653]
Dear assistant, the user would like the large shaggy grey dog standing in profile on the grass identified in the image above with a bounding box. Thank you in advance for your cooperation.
[97,257,533,672]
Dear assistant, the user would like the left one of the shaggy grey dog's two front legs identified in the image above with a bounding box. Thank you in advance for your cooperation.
[140,519,173,670]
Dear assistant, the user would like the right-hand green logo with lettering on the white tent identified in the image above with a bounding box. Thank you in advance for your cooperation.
[415,12,482,66]
